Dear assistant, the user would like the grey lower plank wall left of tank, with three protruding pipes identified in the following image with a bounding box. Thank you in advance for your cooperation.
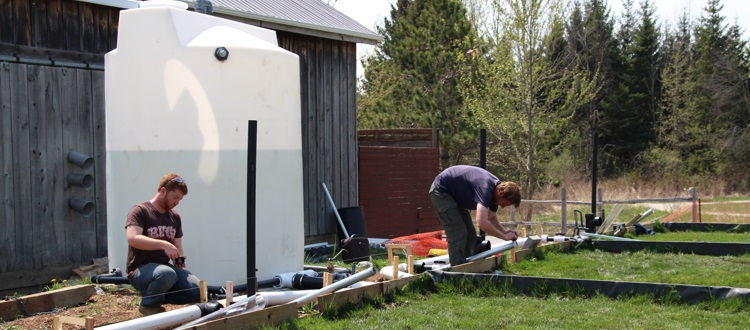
[0,62,107,291]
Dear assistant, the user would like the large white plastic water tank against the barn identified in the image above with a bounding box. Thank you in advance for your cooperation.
[105,6,304,285]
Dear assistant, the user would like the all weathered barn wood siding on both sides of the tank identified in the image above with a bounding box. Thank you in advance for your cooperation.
[0,0,359,291]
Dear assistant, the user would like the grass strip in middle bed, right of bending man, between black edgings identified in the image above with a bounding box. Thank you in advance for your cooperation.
[503,249,750,288]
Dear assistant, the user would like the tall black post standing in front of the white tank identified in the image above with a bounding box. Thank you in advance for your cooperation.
[247,120,258,297]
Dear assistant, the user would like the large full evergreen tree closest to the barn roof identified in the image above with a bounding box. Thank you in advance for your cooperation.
[357,0,478,167]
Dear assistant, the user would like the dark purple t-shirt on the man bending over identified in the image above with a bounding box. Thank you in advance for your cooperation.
[434,165,500,212]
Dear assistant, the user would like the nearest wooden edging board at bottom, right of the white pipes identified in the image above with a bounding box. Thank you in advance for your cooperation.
[190,302,297,330]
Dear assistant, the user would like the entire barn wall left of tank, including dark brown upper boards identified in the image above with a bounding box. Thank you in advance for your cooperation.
[0,0,119,291]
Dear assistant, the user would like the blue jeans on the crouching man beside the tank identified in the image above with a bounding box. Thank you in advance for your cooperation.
[131,262,200,306]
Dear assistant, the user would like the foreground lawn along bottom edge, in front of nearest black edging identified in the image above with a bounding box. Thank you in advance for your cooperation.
[274,279,750,329]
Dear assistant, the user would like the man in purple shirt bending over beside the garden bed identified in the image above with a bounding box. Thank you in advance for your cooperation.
[430,165,521,266]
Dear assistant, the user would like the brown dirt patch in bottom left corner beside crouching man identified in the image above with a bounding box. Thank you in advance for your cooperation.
[0,284,191,330]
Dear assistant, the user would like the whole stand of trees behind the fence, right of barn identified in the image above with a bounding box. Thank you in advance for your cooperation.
[358,0,750,193]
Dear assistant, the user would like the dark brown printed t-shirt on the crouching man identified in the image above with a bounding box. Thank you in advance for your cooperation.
[125,201,182,282]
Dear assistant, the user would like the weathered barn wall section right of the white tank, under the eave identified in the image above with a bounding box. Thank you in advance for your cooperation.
[276,31,359,244]
